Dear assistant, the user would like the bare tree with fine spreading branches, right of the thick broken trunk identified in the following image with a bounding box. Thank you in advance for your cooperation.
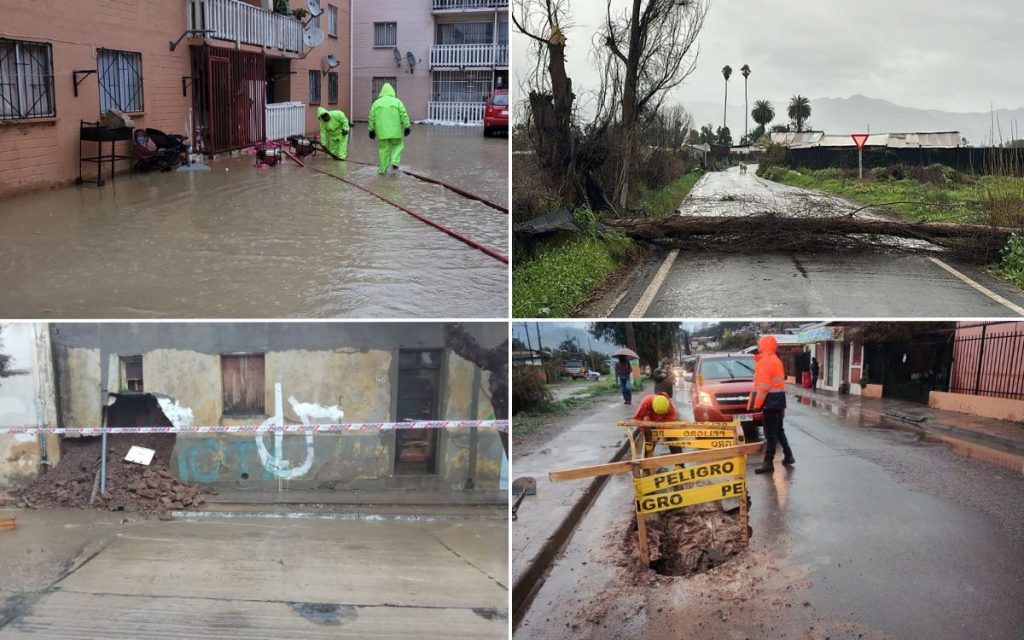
[598,0,710,207]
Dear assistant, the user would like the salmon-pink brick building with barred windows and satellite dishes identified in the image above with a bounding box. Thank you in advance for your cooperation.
[0,0,351,197]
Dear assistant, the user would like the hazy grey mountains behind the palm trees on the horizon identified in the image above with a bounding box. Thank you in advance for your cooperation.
[683,95,1024,146]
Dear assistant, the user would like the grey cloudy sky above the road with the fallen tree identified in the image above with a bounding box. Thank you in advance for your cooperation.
[512,0,1024,112]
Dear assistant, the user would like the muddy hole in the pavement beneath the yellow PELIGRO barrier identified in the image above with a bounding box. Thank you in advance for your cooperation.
[623,502,744,575]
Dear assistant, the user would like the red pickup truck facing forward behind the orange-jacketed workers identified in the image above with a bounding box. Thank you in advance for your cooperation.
[690,353,764,442]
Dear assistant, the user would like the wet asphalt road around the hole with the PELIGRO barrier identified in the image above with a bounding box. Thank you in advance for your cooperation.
[515,385,1024,640]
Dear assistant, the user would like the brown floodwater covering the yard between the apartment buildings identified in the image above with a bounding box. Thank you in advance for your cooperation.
[0,124,509,318]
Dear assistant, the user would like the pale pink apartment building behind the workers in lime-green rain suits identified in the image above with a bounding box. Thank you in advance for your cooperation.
[352,0,509,124]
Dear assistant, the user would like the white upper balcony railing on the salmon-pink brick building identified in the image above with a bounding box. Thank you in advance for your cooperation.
[185,0,302,53]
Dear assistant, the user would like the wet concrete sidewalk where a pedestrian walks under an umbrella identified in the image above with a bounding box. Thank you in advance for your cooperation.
[509,385,650,611]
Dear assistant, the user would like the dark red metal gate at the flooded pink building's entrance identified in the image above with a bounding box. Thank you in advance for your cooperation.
[191,45,266,154]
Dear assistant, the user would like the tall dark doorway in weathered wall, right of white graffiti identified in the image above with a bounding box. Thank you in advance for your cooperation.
[394,349,444,475]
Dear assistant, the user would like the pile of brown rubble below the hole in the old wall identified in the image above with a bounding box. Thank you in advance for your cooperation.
[17,433,206,519]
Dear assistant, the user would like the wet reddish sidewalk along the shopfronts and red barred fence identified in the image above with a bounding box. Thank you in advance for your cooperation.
[786,384,1024,473]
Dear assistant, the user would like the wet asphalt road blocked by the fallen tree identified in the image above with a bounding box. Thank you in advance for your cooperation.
[591,166,1024,317]
